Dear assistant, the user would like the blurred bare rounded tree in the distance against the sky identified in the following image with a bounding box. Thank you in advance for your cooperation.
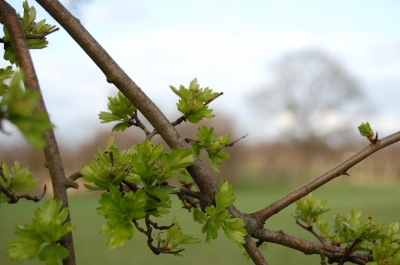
[250,49,365,140]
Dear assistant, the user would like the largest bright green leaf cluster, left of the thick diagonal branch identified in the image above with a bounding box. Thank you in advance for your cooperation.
[81,137,197,249]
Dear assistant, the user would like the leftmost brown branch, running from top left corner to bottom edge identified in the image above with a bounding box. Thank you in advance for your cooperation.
[0,0,75,265]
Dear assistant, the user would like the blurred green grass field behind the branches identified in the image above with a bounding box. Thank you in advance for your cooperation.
[0,182,400,265]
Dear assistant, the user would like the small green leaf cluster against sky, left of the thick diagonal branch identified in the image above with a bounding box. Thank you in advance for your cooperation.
[99,92,137,132]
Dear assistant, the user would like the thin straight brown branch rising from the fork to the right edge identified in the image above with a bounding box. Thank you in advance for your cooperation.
[252,132,400,222]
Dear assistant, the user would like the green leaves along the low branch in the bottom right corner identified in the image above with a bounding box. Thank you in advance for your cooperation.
[293,194,400,260]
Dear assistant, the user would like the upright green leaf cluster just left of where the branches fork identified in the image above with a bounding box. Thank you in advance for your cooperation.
[202,180,247,244]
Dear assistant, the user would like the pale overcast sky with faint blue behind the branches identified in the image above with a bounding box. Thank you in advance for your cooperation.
[0,0,400,143]
